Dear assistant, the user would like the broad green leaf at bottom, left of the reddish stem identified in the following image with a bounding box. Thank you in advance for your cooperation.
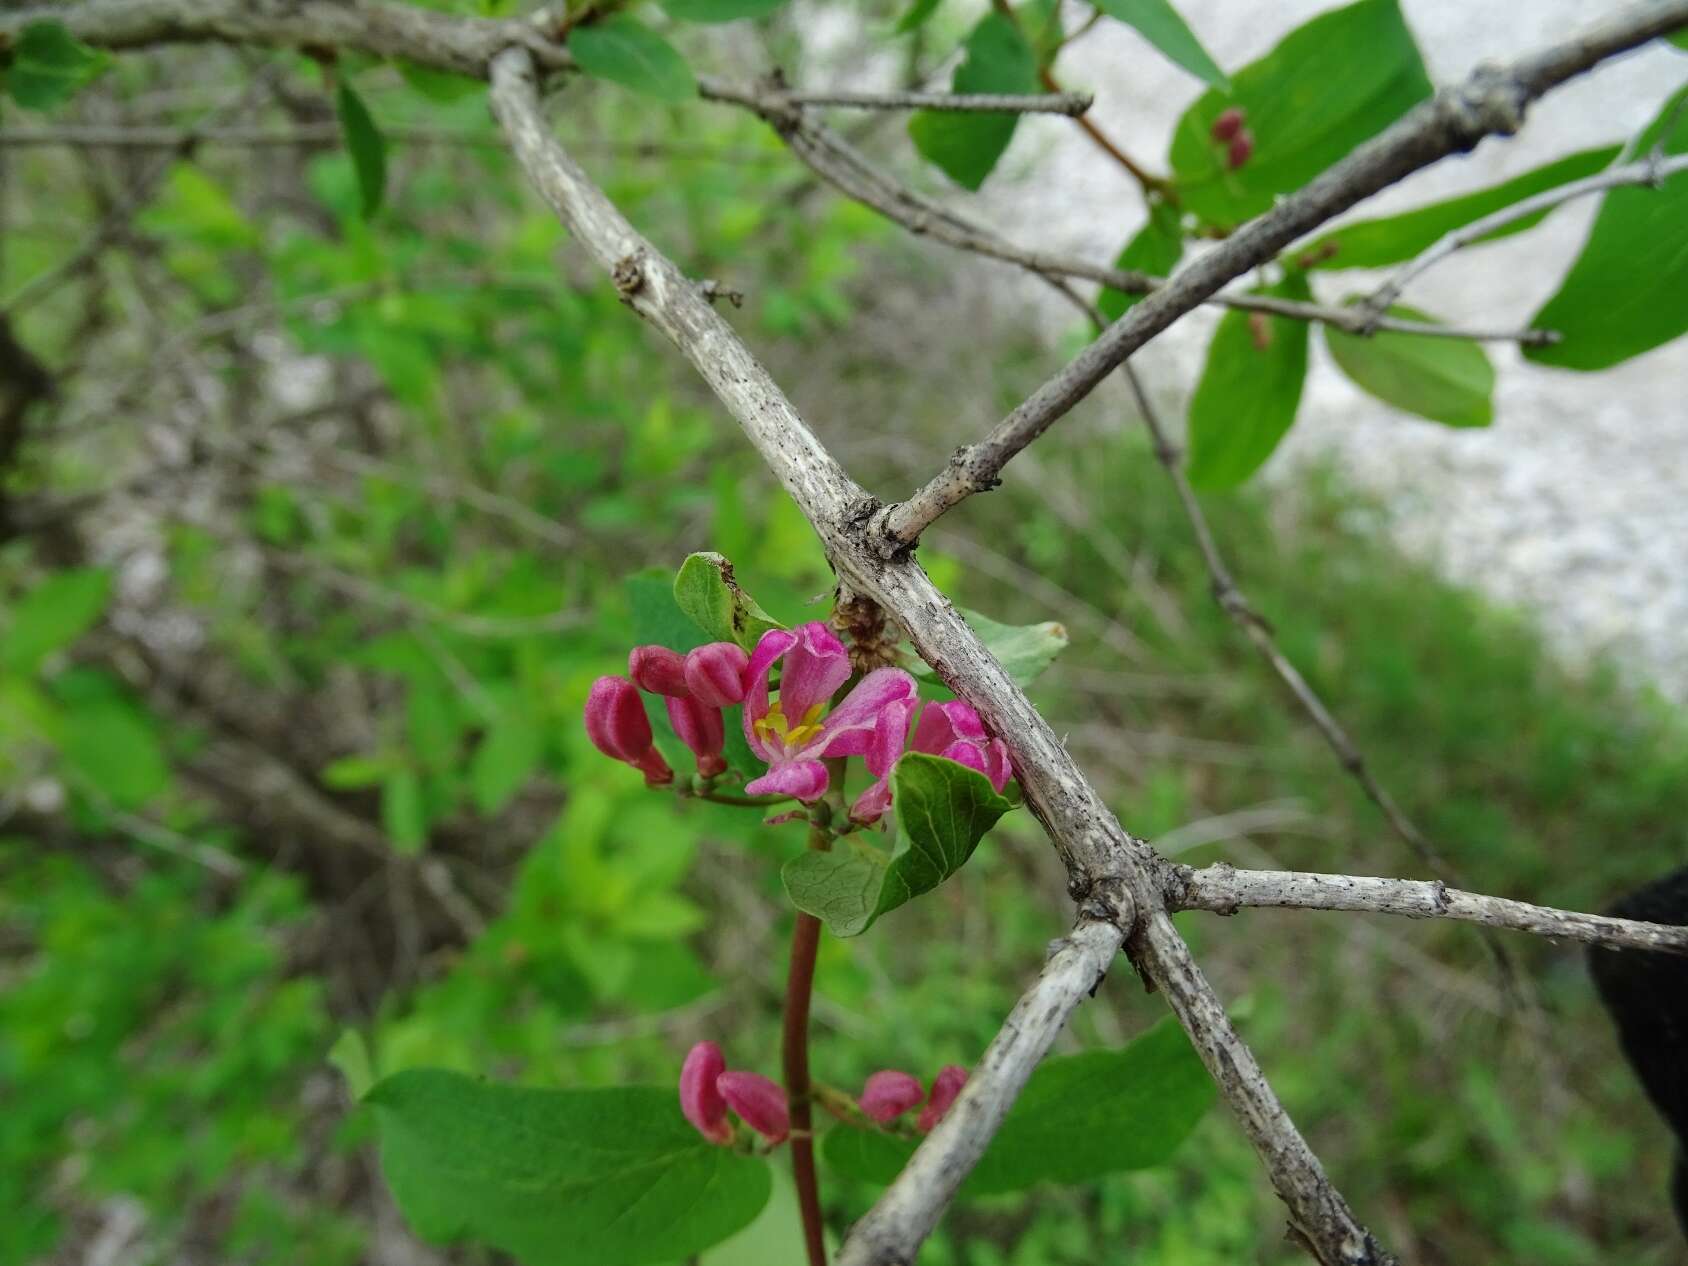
[365,1069,770,1266]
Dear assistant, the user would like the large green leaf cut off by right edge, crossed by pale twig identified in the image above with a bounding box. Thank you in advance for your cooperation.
[1524,88,1688,370]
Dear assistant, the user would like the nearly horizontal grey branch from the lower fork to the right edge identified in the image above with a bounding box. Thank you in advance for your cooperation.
[1168,863,1688,954]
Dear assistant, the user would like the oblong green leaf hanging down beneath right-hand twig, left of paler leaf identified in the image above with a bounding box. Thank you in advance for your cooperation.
[1188,275,1310,488]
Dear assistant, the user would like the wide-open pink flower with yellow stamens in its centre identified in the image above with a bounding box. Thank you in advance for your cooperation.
[744,621,915,802]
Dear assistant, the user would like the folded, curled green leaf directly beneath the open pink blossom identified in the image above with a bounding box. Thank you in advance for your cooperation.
[782,751,1013,937]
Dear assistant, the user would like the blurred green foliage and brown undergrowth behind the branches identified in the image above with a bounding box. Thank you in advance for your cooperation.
[0,3,1688,1266]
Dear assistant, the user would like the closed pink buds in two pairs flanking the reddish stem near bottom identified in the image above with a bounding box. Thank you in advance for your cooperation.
[680,1041,967,1146]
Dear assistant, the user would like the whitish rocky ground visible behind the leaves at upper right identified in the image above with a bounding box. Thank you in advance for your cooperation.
[982,0,1688,701]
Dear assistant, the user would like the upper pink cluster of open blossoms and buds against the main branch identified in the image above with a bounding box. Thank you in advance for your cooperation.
[586,621,1011,824]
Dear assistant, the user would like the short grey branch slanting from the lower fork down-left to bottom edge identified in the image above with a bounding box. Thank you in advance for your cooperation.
[836,920,1124,1266]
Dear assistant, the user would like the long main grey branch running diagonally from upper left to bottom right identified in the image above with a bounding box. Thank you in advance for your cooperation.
[493,49,1393,1266]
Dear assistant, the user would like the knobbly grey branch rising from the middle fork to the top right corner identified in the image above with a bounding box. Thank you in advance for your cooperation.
[876,0,1688,555]
